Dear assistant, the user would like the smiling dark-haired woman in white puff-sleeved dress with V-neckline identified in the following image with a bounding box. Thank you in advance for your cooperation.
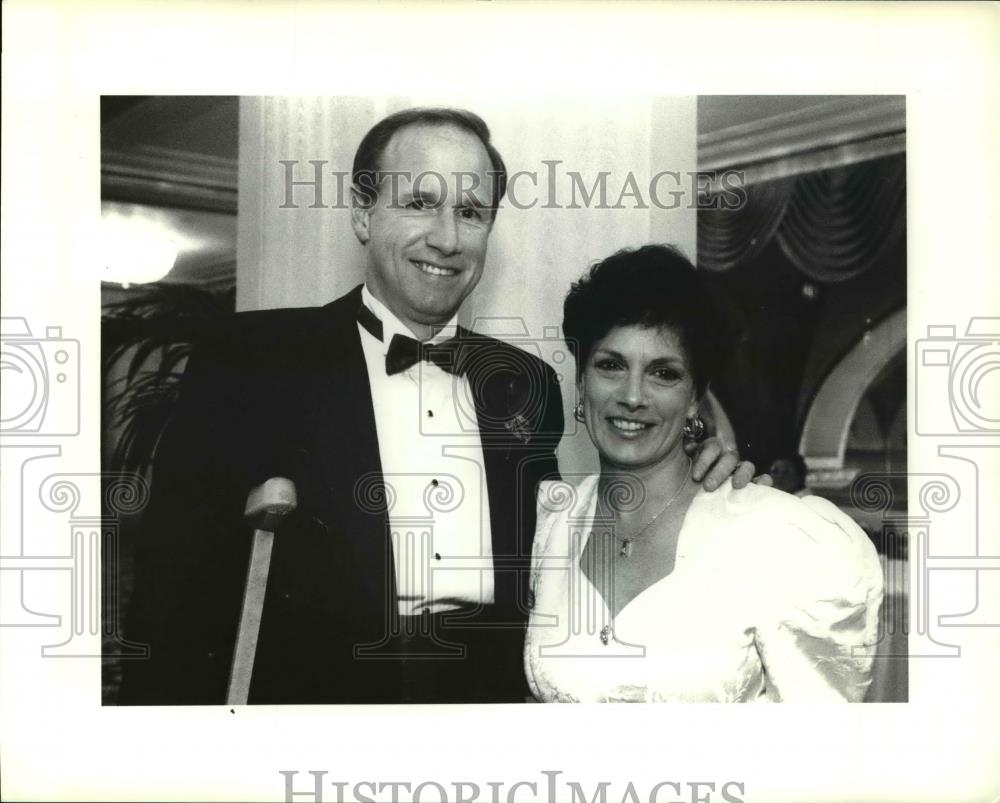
[525,246,882,702]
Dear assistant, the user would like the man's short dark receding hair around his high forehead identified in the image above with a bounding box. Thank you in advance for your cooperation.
[351,107,507,219]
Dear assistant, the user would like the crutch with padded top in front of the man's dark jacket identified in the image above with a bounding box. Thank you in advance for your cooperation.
[226,477,297,705]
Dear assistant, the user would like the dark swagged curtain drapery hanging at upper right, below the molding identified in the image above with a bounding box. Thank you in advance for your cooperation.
[698,154,906,283]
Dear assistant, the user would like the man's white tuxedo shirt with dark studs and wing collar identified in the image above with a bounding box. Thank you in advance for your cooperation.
[362,285,494,616]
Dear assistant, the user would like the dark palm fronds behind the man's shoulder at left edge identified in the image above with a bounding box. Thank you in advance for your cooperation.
[101,284,235,474]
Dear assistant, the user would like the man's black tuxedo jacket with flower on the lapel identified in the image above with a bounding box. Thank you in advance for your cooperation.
[120,286,563,704]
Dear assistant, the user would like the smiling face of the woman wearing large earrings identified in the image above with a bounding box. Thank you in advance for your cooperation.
[579,325,698,469]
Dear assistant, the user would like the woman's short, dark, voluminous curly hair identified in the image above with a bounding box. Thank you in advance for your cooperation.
[563,245,732,398]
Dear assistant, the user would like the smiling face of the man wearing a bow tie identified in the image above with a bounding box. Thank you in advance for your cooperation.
[353,124,493,337]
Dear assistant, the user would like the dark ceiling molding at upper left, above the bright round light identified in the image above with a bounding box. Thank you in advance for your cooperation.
[101,145,238,214]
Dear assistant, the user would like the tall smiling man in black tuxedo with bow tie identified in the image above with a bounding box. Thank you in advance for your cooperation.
[121,109,752,704]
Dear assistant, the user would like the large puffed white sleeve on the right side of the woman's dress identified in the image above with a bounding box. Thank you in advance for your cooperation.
[755,496,883,702]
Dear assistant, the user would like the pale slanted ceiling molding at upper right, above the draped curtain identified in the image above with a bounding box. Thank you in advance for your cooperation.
[698,95,906,185]
